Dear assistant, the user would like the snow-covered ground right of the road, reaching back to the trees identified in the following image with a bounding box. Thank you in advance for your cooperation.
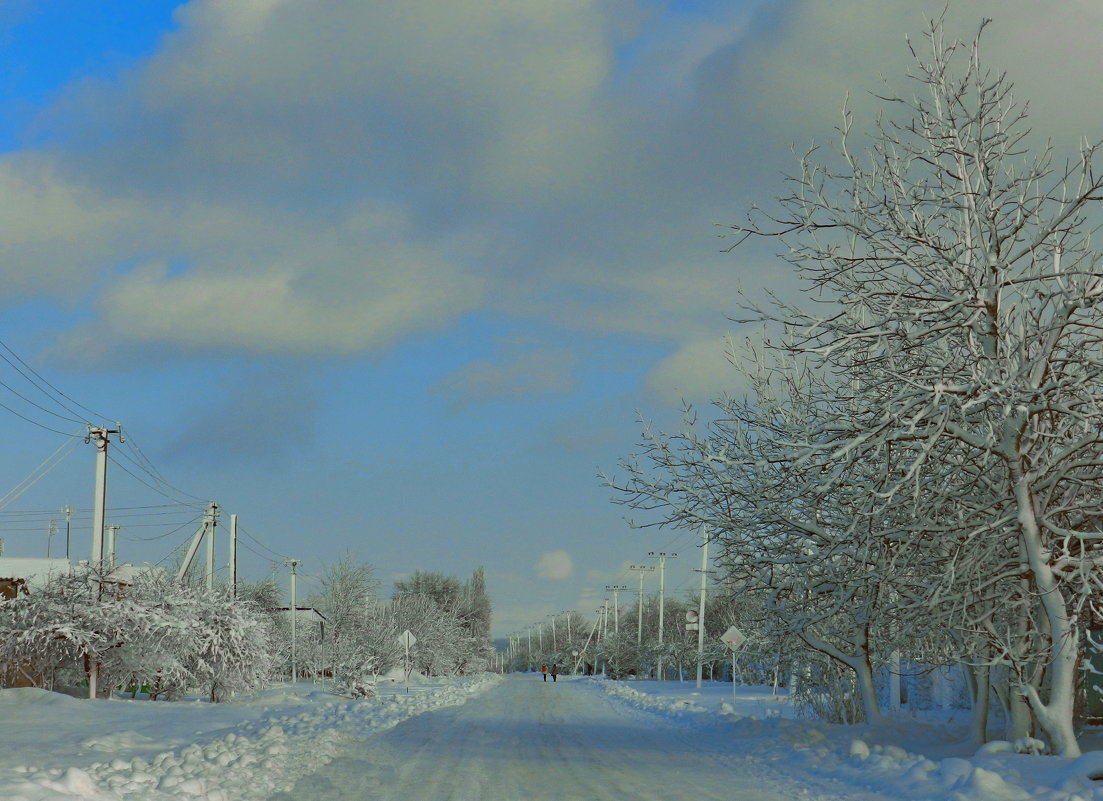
[593,680,1103,801]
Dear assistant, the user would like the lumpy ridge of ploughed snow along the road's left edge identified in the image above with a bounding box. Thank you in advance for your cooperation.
[0,673,501,801]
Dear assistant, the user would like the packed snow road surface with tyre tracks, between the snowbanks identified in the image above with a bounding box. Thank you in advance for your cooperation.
[272,676,833,801]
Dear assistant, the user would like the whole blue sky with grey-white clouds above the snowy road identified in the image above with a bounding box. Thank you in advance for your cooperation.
[0,0,1103,634]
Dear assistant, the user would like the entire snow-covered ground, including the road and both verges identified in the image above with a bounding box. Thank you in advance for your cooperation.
[0,675,1103,801]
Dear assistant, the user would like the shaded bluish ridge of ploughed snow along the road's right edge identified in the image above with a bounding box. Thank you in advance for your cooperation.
[596,682,1103,801]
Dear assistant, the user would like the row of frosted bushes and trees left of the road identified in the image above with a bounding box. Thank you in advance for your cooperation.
[0,557,491,701]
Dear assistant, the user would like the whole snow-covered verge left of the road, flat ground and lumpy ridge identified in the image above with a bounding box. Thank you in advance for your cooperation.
[0,674,500,801]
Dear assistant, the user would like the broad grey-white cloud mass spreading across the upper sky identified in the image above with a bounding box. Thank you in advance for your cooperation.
[0,0,1103,375]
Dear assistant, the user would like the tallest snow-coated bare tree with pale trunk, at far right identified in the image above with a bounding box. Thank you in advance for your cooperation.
[719,21,1103,756]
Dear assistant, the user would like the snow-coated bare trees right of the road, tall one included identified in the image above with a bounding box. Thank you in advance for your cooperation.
[609,20,1103,756]
